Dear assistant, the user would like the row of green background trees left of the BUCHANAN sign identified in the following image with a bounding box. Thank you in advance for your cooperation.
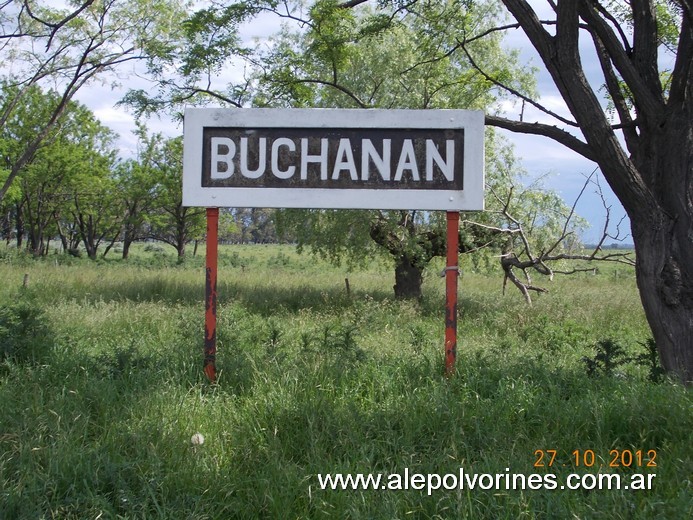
[0,85,204,259]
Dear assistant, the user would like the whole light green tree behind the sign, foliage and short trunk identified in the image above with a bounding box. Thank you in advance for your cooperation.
[254,1,533,298]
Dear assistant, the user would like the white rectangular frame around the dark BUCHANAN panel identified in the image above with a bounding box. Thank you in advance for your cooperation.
[183,108,484,211]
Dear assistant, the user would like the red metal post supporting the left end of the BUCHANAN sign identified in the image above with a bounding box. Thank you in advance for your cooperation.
[203,208,219,383]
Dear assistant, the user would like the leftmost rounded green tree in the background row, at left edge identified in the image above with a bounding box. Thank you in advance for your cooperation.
[0,80,115,255]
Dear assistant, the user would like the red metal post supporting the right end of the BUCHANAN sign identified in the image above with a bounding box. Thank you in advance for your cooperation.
[445,211,460,376]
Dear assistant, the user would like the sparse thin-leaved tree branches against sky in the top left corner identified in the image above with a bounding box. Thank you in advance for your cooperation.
[0,0,189,201]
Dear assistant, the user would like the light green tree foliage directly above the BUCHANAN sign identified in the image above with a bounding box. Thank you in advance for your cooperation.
[253,0,534,111]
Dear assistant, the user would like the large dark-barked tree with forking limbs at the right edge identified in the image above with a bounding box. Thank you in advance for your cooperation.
[444,0,693,384]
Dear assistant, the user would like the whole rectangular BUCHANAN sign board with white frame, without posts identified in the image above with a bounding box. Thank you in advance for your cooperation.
[183,109,484,211]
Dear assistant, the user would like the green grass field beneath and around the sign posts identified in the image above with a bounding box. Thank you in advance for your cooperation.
[0,242,693,520]
